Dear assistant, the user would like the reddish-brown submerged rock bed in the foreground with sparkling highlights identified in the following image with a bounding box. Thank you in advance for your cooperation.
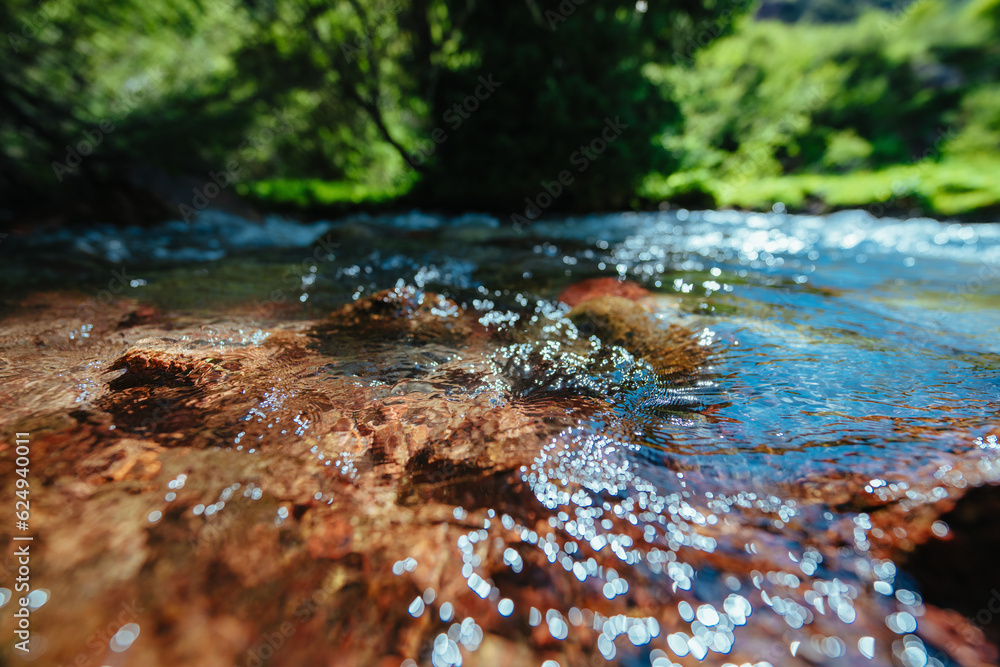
[0,286,985,667]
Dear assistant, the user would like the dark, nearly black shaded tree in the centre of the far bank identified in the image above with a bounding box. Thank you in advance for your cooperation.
[417,0,739,217]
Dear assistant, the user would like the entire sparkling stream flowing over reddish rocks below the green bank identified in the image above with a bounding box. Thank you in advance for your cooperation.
[0,210,1000,667]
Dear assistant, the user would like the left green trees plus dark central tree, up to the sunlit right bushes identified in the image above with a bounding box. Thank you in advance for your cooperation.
[0,0,742,218]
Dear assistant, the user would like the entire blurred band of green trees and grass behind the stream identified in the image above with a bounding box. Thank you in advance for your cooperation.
[0,0,1000,222]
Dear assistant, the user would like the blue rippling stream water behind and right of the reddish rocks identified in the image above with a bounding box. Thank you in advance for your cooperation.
[21,210,1000,468]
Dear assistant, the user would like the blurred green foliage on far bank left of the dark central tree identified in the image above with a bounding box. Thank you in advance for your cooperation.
[0,0,446,216]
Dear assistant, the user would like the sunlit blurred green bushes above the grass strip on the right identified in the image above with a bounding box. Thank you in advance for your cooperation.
[657,0,1000,181]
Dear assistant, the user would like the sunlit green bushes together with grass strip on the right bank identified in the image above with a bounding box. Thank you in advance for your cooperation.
[642,0,1000,214]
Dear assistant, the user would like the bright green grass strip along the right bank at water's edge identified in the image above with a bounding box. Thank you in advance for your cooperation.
[639,155,1000,217]
